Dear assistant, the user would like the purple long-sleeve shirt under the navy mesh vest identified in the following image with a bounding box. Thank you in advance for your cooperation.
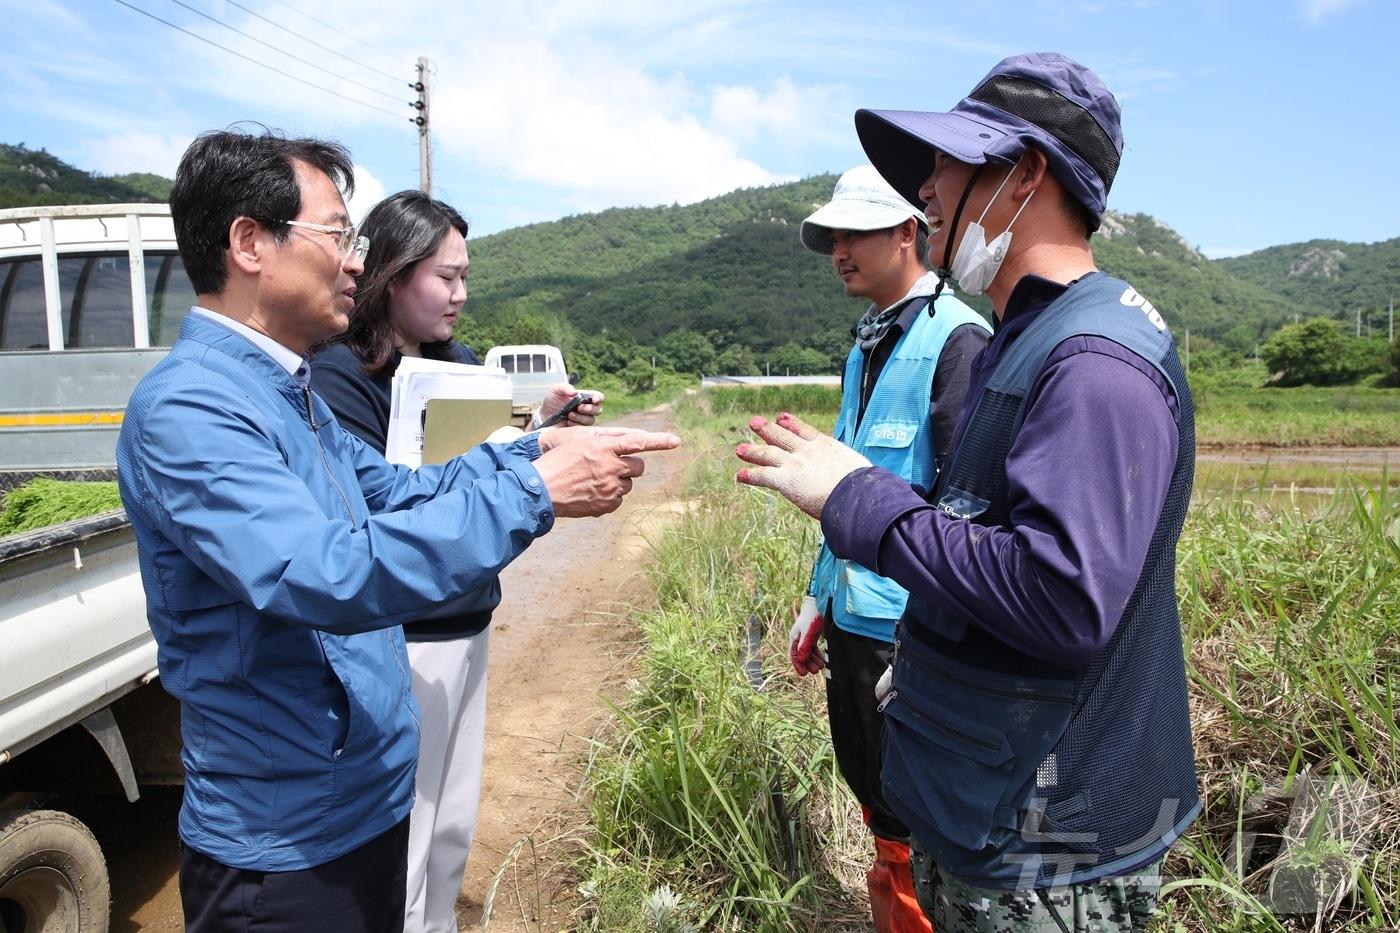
[822,276,1177,667]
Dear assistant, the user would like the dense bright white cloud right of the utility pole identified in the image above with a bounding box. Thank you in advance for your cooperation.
[433,35,801,210]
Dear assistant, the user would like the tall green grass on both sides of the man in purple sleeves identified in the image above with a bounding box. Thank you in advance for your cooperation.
[584,387,1400,933]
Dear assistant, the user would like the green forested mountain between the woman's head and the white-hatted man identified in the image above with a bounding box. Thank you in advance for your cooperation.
[469,175,860,356]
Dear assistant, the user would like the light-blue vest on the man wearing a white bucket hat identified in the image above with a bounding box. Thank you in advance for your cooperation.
[809,294,991,642]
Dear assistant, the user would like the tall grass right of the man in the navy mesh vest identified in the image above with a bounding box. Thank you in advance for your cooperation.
[1165,483,1400,930]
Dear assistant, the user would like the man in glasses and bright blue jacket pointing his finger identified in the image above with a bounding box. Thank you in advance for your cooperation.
[118,132,679,933]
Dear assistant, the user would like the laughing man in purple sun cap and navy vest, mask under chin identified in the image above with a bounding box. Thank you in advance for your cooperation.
[741,53,1200,933]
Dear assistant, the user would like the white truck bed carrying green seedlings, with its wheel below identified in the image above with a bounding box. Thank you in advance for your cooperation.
[0,510,183,933]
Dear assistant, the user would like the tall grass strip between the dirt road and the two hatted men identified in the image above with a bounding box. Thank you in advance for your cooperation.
[582,394,869,930]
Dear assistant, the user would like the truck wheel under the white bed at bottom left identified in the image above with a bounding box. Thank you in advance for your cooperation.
[0,810,112,933]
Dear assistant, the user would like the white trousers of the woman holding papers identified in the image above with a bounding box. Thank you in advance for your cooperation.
[403,628,491,933]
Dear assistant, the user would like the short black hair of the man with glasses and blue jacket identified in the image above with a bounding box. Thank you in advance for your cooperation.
[171,129,354,294]
